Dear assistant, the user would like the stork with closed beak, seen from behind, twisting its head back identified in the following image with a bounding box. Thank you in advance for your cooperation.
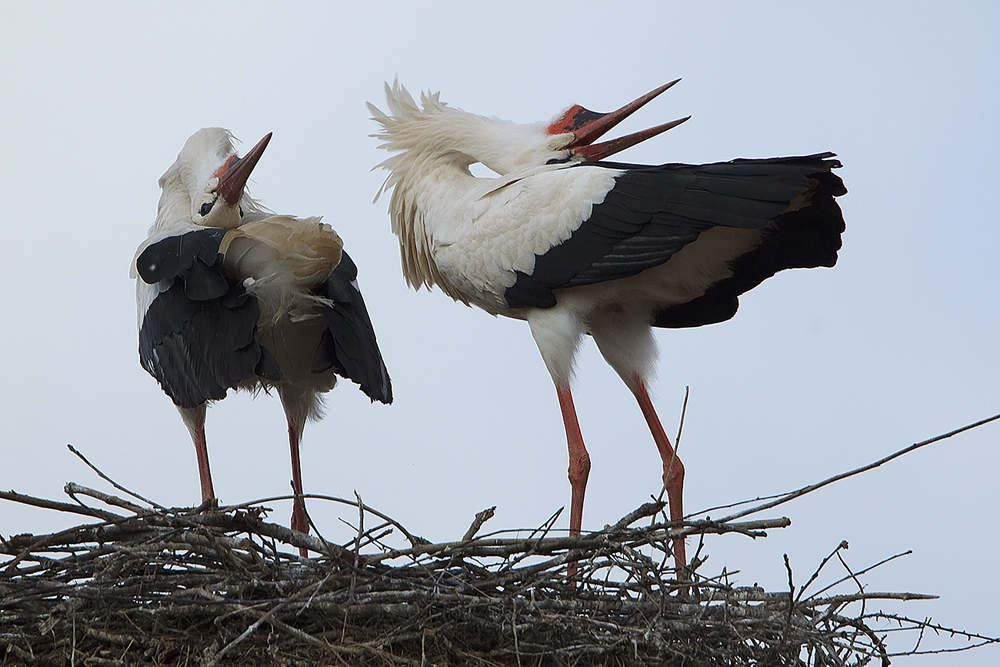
[131,128,392,554]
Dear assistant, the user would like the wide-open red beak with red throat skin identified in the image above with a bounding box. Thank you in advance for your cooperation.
[548,79,691,162]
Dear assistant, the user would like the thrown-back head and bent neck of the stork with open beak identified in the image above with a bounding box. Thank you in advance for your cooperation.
[368,79,690,186]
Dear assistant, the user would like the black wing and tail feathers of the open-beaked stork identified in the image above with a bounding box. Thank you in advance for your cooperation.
[504,153,846,326]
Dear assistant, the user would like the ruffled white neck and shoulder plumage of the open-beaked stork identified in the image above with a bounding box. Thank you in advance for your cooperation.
[369,82,621,317]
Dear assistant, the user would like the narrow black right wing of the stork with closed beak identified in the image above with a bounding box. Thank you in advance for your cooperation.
[312,252,392,403]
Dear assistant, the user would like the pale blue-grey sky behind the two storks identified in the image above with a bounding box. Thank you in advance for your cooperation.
[0,2,1000,665]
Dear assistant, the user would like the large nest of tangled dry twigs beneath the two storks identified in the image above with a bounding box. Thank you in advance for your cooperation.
[0,416,1000,667]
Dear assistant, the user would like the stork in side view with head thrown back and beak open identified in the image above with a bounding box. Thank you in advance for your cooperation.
[368,81,846,568]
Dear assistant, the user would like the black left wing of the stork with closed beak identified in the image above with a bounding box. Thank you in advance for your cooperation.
[136,228,270,408]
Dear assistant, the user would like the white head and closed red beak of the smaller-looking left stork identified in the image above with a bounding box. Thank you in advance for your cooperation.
[157,127,271,229]
